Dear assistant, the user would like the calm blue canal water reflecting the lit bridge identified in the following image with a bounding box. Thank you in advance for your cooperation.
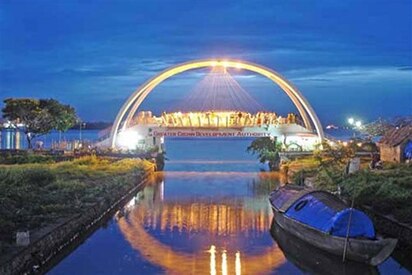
[49,139,409,274]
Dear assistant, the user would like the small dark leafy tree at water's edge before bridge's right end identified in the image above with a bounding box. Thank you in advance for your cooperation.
[246,137,282,171]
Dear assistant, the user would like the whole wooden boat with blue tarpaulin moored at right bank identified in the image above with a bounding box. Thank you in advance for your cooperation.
[269,185,397,266]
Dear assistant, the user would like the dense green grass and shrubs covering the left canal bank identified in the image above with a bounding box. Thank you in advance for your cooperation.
[0,156,151,248]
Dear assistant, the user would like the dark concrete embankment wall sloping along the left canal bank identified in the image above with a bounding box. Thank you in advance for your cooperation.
[0,167,154,275]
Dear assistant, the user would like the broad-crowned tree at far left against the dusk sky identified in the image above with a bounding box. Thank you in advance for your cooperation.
[2,98,76,148]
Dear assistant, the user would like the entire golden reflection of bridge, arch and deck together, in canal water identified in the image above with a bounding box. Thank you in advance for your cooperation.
[114,172,285,275]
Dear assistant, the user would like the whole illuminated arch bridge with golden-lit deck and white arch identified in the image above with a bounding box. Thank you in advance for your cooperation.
[101,59,324,150]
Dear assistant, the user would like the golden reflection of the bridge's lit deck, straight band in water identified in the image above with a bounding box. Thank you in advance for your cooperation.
[133,199,271,237]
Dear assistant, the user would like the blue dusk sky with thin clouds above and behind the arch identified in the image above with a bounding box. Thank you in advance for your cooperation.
[0,0,412,124]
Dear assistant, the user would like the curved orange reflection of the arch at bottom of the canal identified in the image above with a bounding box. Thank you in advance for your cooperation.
[118,213,285,274]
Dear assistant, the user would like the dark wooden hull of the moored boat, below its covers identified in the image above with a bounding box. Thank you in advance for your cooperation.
[272,206,397,266]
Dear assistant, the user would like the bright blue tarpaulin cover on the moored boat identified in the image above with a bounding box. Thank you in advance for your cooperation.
[285,193,375,238]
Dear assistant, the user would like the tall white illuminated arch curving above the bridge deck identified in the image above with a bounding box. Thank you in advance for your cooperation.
[110,59,324,147]
